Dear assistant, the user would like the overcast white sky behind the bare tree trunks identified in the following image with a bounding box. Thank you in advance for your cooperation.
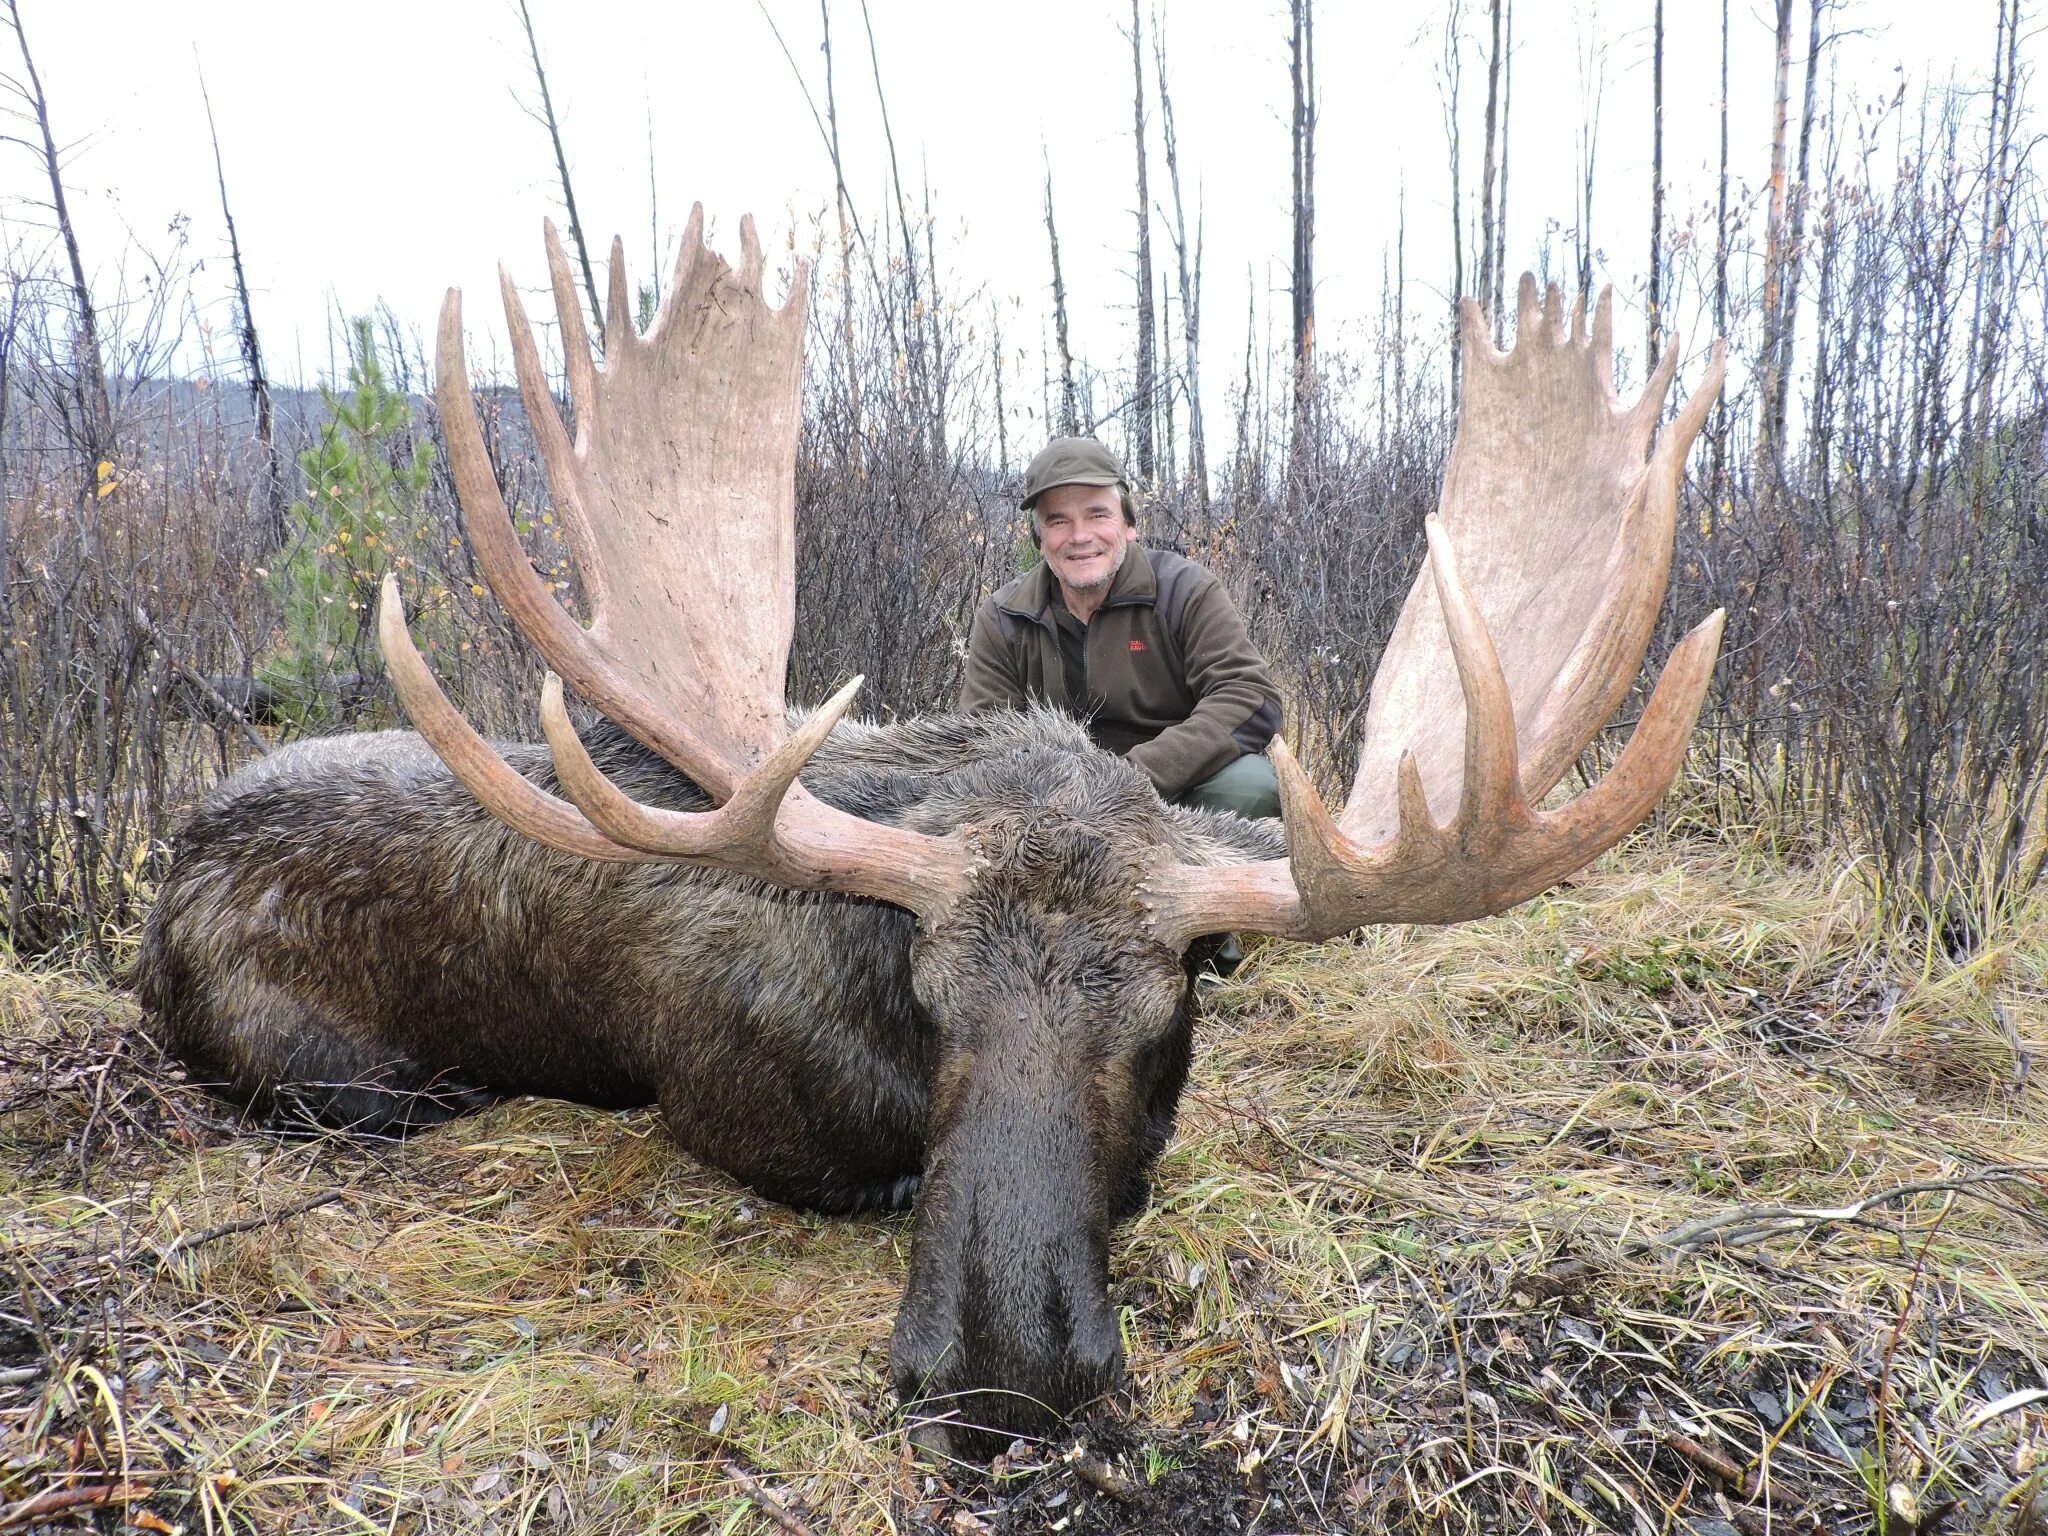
[0,0,2040,428]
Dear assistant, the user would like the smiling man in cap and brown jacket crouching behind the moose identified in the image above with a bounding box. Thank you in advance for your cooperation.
[961,438,1280,817]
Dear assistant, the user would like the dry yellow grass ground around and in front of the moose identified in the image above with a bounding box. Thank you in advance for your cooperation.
[0,811,2048,1536]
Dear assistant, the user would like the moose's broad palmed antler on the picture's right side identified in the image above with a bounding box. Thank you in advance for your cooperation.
[1147,276,1724,946]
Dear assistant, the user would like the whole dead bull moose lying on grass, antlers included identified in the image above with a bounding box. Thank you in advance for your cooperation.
[137,209,1722,1454]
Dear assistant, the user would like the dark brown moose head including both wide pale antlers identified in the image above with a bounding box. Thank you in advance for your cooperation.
[379,209,1722,1450]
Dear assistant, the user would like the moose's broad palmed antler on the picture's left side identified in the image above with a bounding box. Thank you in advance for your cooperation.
[377,205,971,920]
